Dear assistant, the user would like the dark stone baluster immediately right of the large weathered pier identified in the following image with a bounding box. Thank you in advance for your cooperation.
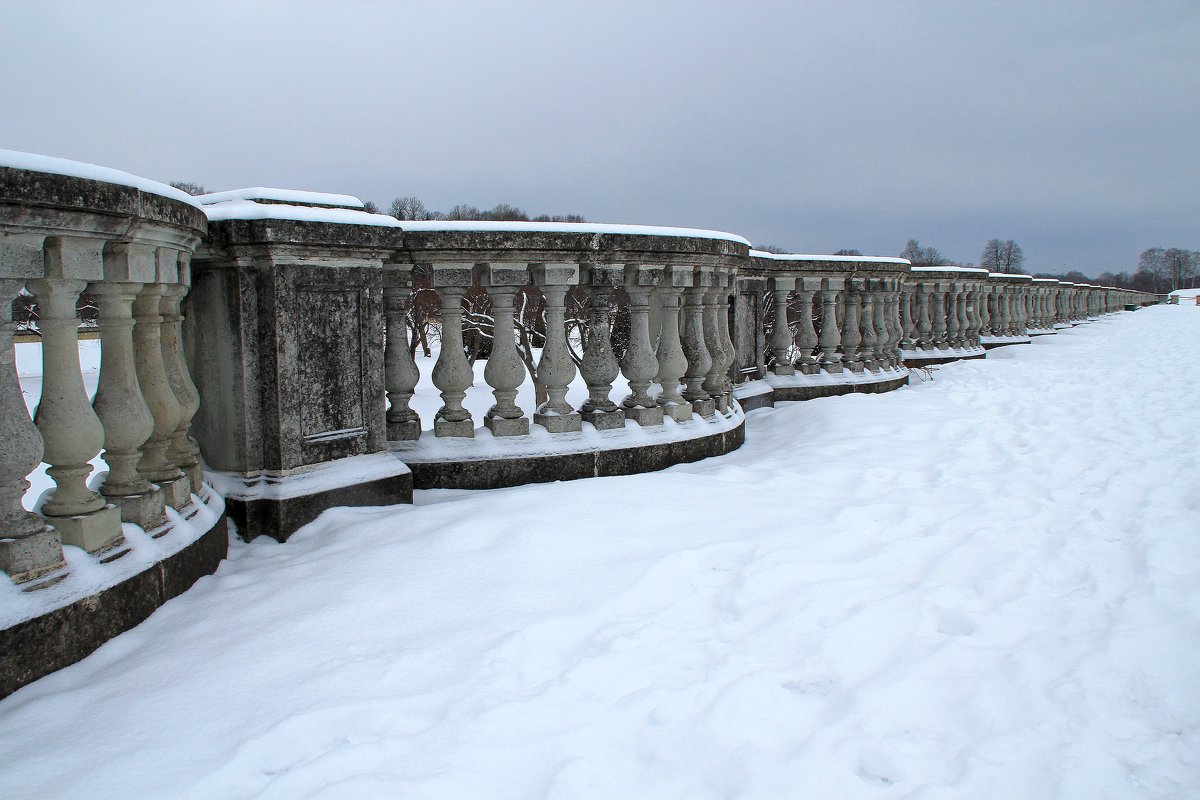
[383,264,424,441]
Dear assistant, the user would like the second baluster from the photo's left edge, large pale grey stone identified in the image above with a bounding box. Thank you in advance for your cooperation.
[29,236,123,553]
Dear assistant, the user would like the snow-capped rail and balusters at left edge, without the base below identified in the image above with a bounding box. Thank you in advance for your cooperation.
[0,154,206,587]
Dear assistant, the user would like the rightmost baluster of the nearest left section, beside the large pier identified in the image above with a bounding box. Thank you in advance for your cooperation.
[158,253,204,499]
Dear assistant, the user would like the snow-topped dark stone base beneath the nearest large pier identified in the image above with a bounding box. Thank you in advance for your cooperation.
[213,450,420,542]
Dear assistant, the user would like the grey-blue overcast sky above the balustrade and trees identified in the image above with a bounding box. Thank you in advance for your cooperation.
[0,0,1200,275]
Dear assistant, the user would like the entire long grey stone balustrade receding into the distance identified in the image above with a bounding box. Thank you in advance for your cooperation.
[0,151,1160,696]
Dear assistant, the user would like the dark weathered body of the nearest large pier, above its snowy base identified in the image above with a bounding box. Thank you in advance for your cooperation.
[190,221,397,474]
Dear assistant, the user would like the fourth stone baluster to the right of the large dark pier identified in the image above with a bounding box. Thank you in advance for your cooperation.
[529,264,583,433]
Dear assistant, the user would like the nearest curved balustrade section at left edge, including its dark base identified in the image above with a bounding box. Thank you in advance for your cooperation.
[0,151,228,696]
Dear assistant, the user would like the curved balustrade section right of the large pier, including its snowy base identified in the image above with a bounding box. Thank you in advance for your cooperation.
[384,222,749,488]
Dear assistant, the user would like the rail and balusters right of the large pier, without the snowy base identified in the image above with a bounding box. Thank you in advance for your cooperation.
[386,222,749,441]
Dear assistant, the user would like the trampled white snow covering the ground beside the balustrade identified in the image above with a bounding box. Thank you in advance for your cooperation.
[0,306,1200,800]
